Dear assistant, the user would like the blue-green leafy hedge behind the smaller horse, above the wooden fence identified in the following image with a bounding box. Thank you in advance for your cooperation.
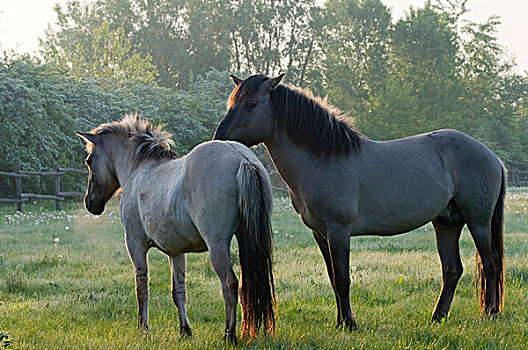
[0,57,231,171]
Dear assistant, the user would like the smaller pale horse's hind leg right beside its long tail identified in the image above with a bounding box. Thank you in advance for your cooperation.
[209,243,238,344]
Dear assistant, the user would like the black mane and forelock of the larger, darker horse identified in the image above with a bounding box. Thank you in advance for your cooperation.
[234,75,363,158]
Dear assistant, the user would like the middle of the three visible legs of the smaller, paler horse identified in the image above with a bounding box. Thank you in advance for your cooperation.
[169,254,192,337]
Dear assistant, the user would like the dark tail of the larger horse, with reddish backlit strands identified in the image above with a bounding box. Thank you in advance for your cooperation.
[475,167,506,313]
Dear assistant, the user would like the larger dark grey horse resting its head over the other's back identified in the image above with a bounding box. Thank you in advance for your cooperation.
[213,74,506,329]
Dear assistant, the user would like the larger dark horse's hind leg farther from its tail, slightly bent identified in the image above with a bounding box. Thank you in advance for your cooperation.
[431,219,464,322]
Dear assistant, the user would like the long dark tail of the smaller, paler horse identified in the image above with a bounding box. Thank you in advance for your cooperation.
[236,160,277,338]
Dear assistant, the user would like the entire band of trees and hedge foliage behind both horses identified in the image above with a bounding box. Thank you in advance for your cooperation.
[0,0,528,174]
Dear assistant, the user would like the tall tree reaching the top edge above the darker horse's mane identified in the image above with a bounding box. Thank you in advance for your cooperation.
[323,0,392,116]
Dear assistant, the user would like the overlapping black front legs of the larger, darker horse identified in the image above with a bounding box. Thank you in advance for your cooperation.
[314,227,357,330]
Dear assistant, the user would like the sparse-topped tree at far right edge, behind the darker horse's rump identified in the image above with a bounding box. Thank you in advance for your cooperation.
[460,16,528,166]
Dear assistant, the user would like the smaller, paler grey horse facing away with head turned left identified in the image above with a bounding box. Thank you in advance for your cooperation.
[76,115,276,344]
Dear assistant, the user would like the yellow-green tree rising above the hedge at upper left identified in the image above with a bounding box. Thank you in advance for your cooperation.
[40,1,157,83]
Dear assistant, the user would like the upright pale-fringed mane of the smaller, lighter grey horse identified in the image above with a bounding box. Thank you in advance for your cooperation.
[91,114,178,166]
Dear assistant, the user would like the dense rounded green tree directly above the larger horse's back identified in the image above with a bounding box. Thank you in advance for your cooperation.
[357,3,461,139]
